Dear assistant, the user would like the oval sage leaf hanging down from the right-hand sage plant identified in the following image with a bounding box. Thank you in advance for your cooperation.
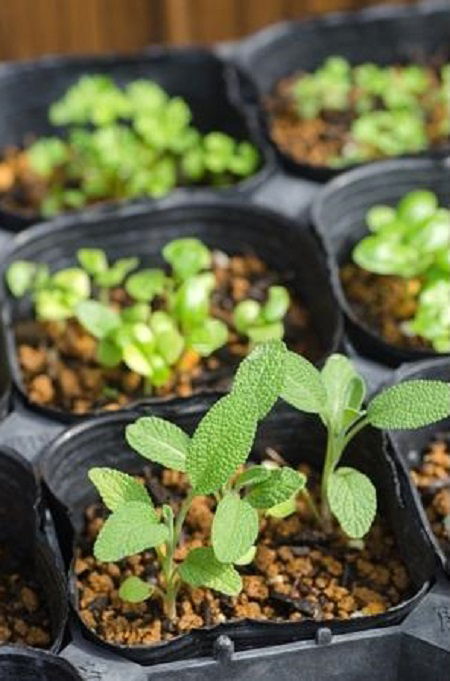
[327,467,377,539]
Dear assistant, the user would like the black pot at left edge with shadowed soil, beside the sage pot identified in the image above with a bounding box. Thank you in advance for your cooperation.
[0,446,68,648]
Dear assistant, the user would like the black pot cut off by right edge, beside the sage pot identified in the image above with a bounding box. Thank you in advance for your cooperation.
[389,358,450,573]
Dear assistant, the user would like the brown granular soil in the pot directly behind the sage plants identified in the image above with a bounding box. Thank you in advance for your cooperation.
[15,253,322,414]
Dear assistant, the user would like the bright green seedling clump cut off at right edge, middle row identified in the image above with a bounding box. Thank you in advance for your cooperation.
[353,189,450,352]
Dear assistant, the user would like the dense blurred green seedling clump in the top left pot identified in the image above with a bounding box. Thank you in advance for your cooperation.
[26,75,260,216]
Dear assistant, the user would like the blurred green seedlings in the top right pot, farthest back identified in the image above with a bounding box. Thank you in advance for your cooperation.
[292,57,450,166]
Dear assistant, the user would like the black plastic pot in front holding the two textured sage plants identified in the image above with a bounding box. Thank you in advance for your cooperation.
[39,399,435,664]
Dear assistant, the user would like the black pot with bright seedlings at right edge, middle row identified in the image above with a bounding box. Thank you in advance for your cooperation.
[312,157,450,366]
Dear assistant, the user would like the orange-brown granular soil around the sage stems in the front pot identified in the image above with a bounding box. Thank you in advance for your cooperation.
[74,456,412,645]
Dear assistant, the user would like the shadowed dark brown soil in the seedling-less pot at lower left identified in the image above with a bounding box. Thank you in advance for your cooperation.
[0,545,51,648]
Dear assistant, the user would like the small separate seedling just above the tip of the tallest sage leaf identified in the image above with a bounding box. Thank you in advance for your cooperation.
[233,286,290,343]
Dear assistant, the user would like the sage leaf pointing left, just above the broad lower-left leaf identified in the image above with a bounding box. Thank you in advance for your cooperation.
[88,468,152,511]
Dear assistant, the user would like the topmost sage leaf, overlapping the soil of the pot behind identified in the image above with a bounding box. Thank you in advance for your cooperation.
[232,340,287,419]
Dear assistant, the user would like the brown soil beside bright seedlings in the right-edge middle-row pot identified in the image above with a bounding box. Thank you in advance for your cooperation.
[341,263,433,350]
